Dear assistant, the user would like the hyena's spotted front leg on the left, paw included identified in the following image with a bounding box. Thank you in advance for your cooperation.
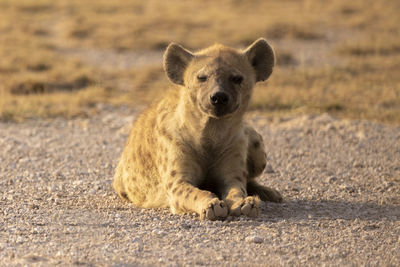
[163,156,228,220]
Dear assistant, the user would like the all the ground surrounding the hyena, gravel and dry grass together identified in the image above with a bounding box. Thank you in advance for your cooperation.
[0,0,400,266]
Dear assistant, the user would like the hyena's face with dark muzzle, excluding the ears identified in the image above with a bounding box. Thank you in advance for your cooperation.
[184,51,250,118]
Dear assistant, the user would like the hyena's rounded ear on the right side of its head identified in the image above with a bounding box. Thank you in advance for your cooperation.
[244,38,275,82]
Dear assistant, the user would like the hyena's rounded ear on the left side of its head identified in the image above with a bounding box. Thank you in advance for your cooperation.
[164,43,194,85]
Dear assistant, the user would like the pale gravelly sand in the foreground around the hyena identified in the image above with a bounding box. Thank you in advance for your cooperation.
[0,107,400,266]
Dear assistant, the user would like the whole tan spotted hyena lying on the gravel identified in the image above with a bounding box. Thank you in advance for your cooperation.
[113,39,282,220]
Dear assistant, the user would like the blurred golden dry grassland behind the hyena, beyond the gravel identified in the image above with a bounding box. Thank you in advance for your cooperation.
[0,0,400,124]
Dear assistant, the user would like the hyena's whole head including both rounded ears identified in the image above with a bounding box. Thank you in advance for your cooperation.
[164,39,275,118]
